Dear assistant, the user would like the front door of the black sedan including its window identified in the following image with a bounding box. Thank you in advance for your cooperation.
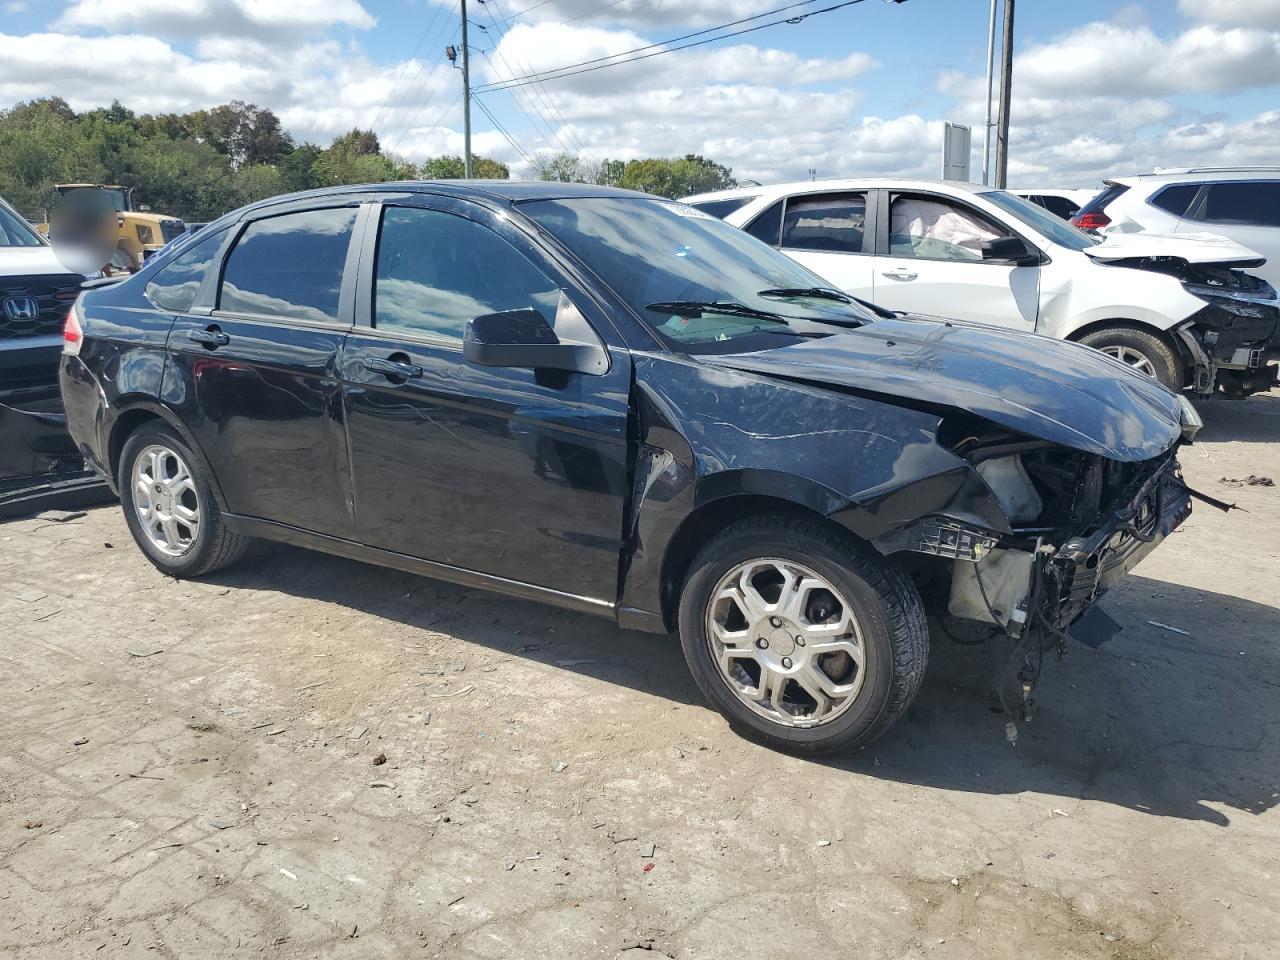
[342,197,631,602]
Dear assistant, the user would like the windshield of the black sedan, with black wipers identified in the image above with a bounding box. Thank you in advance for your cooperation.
[520,197,873,353]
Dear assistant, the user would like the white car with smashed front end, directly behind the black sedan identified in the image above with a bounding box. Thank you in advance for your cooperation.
[685,179,1280,396]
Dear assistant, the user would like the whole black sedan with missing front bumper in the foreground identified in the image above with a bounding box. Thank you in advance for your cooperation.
[61,180,1198,753]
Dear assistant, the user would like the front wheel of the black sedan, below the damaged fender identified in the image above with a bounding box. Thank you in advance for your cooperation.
[680,516,929,756]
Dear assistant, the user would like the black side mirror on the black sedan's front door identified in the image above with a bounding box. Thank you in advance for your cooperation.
[462,310,609,376]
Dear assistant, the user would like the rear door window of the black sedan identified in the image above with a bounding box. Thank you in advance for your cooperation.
[218,207,356,323]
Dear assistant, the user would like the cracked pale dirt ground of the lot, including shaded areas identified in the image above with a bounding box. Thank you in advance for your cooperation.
[0,394,1280,960]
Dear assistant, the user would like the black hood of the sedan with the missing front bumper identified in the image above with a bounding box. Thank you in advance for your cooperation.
[699,316,1181,461]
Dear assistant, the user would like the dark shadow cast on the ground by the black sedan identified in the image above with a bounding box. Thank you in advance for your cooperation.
[202,535,1280,826]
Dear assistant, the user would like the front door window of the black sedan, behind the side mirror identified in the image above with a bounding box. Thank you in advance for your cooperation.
[374,207,561,340]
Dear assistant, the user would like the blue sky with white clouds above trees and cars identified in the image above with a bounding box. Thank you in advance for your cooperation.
[0,0,1280,187]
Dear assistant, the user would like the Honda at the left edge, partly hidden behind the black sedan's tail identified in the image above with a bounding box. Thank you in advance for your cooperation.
[0,200,99,517]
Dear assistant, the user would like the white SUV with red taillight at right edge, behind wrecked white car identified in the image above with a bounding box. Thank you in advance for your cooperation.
[1073,166,1280,293]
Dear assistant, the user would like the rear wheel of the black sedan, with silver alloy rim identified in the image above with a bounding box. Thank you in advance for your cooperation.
[116,421,250,579]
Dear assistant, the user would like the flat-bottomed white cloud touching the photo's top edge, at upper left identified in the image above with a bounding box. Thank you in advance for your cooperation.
[54,0,374,37]
